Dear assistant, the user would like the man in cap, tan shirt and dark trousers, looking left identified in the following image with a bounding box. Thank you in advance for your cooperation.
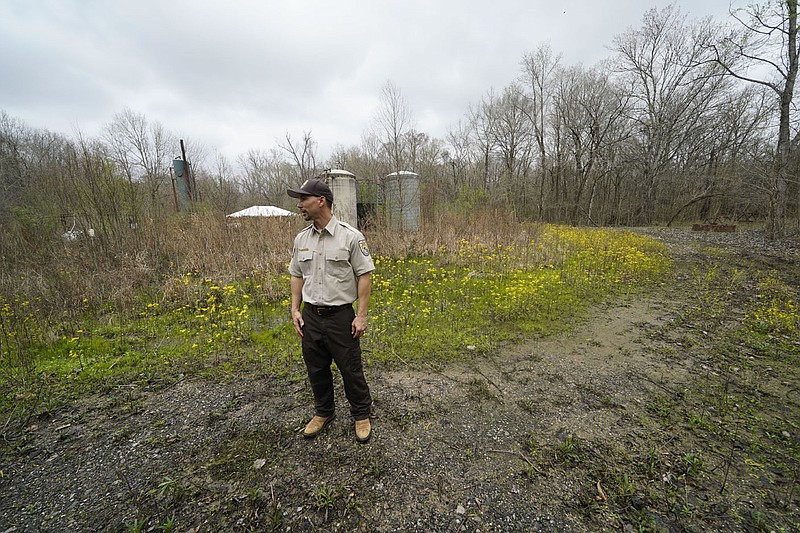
[286,178,375,443]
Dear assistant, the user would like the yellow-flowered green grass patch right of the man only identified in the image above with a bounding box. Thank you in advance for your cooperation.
[365,227,670,363]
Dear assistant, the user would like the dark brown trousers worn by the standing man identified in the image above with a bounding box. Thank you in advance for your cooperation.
[302,306,372,420]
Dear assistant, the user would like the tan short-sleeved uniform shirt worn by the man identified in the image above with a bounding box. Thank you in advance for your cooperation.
[289,216,375,306]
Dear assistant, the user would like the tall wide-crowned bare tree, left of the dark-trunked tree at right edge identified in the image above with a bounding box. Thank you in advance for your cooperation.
[614,4,728,223]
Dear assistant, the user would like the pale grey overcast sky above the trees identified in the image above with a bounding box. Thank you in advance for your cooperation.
[0,0,740,161]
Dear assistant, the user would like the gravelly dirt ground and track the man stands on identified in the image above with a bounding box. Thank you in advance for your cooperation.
[0,229,800,533]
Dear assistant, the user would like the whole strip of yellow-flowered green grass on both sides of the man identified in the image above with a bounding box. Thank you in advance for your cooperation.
[0,226,668,416]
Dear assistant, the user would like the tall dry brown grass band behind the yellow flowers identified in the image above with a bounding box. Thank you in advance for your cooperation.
[0,208,539,320]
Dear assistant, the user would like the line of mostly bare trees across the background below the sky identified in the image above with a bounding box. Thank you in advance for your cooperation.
[0,0,800,260]
